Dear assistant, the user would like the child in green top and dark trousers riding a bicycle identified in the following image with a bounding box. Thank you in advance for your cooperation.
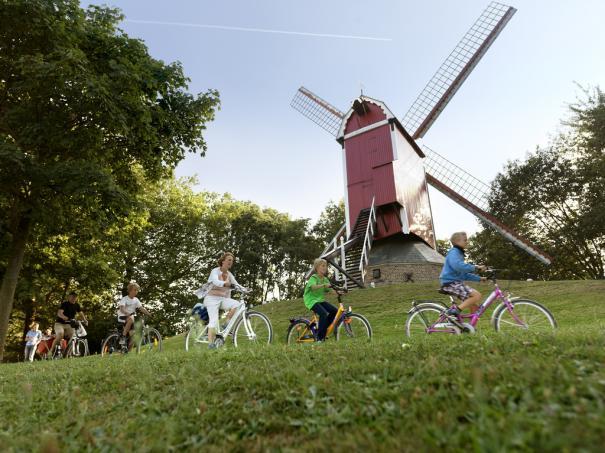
[303,258,338,342]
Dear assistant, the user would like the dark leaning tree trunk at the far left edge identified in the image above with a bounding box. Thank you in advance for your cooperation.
[0,215,31,362]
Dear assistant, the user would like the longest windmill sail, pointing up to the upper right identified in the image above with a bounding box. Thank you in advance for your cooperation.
[401,2,517,139]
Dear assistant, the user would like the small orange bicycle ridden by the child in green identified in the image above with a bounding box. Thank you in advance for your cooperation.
[286,283,372,344]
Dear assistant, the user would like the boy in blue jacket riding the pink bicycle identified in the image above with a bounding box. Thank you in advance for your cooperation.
[439,232,487,318]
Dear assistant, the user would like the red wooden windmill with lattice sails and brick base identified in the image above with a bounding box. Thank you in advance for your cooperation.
[291,2,551,287]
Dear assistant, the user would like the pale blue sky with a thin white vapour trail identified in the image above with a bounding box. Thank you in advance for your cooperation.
[82,0,605,238]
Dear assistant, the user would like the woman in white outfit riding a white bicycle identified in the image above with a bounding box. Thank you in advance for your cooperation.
[204,252,241,349]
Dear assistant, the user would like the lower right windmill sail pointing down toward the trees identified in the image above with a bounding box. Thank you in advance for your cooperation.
[423,146,552,265]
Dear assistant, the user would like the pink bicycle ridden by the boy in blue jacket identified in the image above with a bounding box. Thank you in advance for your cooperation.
[405,269,557,337]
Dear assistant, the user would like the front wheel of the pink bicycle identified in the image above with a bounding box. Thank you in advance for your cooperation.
[494,299,557,333]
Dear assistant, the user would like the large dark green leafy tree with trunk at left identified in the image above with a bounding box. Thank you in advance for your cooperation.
[0,0,218,359]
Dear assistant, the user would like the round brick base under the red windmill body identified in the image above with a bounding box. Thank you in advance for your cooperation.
[365,233,445,285]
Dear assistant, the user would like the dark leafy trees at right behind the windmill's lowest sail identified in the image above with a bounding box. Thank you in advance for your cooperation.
[470,88,605,279]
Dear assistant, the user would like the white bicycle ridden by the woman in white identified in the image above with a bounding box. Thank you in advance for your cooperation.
[185,285,273,351]
